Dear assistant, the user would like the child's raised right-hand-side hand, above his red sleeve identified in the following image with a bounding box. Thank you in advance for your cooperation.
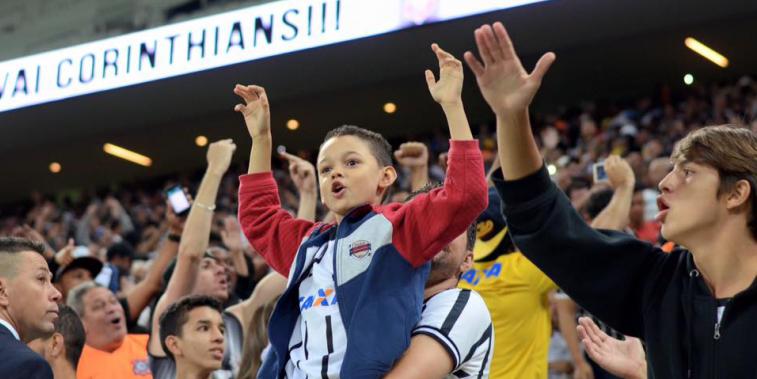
[426,43,463,105]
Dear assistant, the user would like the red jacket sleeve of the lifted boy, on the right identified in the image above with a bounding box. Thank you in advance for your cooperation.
[378,140,489,267]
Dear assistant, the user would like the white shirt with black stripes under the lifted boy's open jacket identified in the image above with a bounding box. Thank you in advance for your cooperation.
[285,241,347,379]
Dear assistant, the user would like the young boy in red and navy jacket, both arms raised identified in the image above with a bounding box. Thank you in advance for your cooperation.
[234,45,487,378]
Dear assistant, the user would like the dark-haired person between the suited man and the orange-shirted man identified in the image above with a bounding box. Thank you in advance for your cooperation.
[27,304,87,379]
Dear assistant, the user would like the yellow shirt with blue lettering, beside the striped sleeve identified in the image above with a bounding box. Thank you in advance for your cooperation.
[459,252,557,379]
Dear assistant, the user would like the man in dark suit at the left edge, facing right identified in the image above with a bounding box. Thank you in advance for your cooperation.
[0,237,60,379]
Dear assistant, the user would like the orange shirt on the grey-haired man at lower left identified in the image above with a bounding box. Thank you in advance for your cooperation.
[76,334,152,379]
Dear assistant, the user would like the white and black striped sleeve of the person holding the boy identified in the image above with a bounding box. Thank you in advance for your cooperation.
[413,288,494,378]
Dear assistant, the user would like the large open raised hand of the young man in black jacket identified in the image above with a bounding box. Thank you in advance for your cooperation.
[464,22,556,115]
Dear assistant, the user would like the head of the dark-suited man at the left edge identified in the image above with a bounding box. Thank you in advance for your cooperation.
[0,251,61,342]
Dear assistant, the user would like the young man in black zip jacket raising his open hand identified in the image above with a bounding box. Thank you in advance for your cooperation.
[465,23,757,379]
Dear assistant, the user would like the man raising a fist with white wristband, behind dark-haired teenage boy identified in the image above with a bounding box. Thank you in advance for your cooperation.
[148,139,285,379]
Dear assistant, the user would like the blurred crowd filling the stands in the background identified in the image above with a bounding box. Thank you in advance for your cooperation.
[0,72,757,378]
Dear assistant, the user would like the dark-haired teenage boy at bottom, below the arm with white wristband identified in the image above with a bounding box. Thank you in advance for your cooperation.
[159,296,226,379]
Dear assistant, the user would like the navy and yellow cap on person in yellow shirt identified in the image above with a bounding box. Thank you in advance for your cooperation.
[473,188,515,261]
